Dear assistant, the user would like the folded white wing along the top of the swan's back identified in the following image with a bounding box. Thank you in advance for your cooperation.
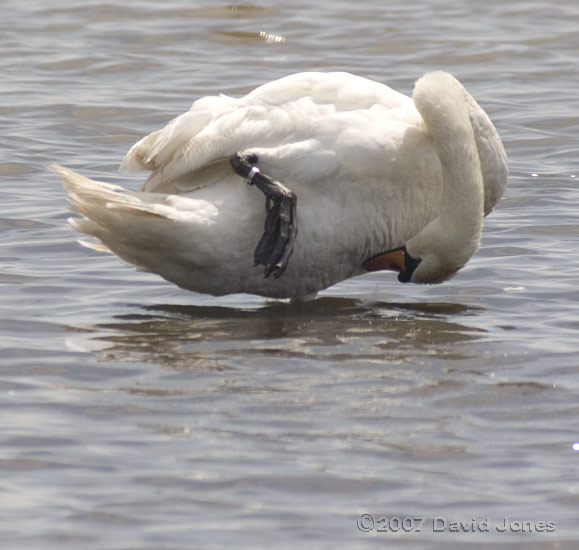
[122,73,413,192]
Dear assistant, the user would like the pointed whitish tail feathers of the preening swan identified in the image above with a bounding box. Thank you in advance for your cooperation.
[51,165,169,269]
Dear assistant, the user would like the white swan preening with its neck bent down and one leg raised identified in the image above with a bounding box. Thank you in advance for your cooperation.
[52,71,507,300]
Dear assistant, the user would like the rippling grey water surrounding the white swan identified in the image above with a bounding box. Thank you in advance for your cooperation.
[0,0,579,550]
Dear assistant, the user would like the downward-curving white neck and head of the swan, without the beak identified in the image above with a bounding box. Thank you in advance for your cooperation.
[407,72,484,283]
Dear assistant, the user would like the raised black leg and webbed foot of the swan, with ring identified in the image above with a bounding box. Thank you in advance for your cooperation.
[229,153,298,279]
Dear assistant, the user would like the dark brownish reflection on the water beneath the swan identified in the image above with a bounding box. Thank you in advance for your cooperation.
[75,298,484,370]
